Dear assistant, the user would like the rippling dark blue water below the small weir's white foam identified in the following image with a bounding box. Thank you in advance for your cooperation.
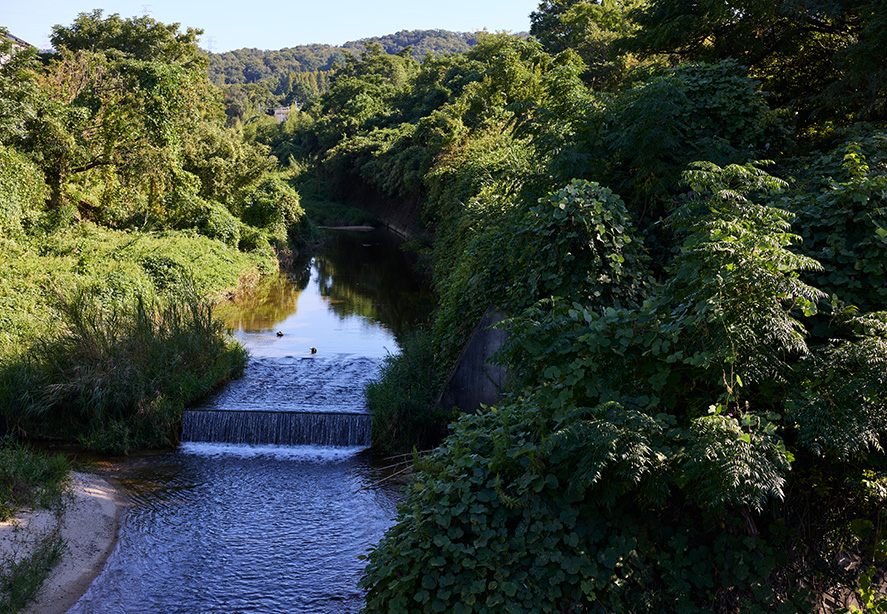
[71,443,398,614]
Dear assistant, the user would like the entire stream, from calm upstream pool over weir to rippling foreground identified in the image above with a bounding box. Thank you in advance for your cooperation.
[70,233,424,614]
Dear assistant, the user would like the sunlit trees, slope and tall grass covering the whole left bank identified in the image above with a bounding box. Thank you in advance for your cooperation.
[0,10,310,453]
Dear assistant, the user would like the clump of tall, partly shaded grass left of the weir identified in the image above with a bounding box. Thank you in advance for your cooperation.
[0,285,246,454]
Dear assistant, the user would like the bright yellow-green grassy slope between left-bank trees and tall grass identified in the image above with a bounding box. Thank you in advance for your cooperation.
[0,222,275,362]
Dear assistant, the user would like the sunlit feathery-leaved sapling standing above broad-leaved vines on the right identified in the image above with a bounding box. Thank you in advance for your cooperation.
[666,163,826,383]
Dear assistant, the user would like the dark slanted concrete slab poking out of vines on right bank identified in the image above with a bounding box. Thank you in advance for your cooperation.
[436,308,508,413]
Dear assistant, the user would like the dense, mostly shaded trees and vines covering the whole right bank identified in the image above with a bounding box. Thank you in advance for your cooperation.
[246,0,887,612]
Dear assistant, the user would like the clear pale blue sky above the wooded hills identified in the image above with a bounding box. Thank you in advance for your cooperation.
[0,0,539,53]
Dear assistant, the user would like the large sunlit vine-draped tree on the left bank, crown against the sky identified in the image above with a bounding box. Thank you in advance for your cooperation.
[22,10,216,214]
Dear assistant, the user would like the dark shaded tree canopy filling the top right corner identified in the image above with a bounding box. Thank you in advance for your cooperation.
[617,0,885,124]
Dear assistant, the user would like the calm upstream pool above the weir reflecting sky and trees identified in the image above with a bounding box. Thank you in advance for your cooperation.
[216,231,430,357]
